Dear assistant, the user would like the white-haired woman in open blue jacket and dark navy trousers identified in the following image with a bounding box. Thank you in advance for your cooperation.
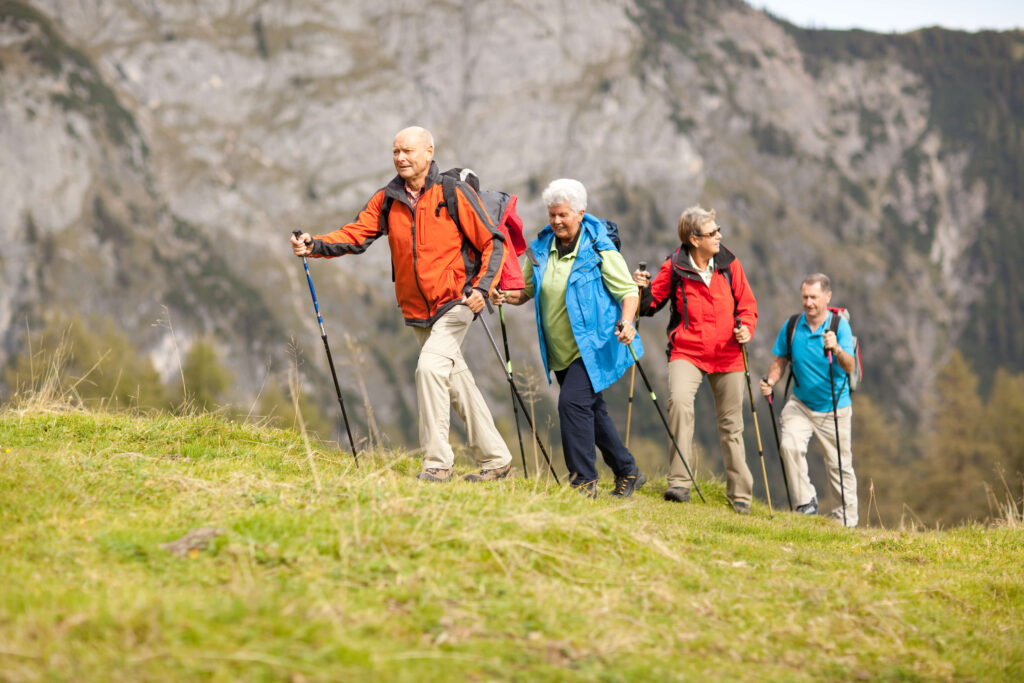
[492,178,647,497]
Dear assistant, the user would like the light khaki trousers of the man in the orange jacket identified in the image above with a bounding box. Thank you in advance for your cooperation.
[413,305,512,470]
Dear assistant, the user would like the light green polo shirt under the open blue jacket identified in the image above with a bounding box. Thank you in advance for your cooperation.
[522,240,639,370]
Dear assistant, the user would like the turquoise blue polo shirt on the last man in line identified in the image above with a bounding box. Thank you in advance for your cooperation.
[771,311,853,413]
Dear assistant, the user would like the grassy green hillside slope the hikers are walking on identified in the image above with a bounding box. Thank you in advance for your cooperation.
[0,410,1024,681]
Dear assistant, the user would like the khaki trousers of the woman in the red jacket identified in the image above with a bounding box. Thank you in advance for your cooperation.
[669,359,754,505]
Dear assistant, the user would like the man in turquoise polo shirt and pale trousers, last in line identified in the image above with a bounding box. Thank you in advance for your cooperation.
[761,273,857,526]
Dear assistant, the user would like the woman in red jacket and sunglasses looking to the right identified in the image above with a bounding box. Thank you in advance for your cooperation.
[634,207,758,514]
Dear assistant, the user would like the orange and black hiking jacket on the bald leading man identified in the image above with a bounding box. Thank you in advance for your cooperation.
[312,162,505,328]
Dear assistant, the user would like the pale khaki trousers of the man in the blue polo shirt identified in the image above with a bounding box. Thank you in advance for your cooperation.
[779,396,858,526]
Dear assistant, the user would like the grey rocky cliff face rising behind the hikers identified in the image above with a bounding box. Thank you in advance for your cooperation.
[0,0,1024,432]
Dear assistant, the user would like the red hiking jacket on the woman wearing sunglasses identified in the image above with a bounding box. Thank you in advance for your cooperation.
[640,247,758,373]
